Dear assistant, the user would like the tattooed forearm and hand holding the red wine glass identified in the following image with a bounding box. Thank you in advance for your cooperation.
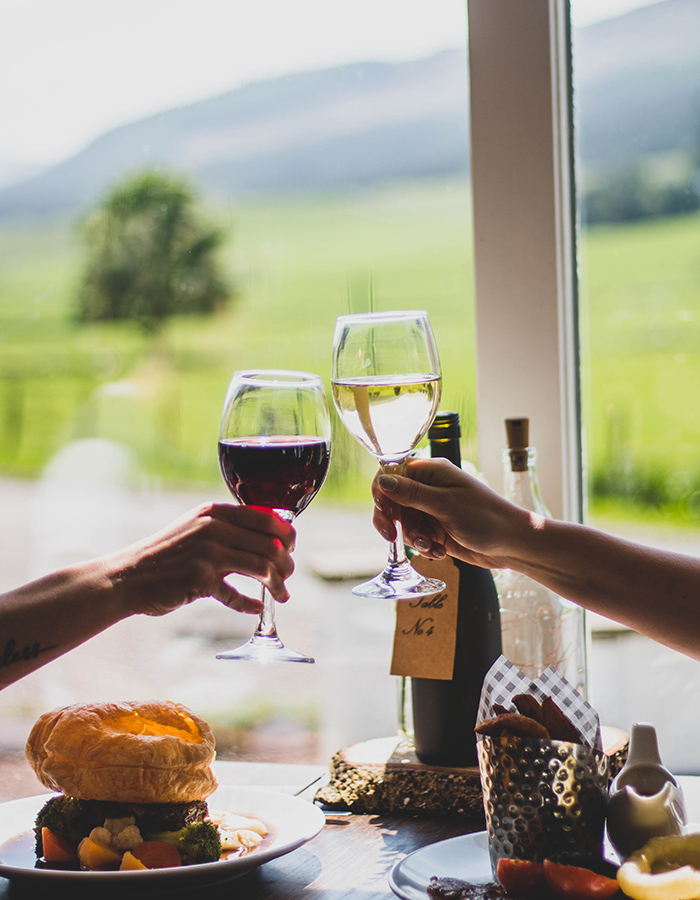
[0,503,295,688]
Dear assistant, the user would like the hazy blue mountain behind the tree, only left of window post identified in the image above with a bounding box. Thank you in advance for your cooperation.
[0,51,468,216]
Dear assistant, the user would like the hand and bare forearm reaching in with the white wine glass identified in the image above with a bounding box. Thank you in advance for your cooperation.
[373,460,700,659]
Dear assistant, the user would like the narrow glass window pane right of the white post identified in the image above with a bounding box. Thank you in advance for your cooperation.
[572,0,700,771]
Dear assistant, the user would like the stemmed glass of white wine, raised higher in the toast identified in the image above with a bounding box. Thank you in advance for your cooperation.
[331,310,445,600]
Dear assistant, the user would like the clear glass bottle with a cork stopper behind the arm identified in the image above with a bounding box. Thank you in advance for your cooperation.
[497,419,587,697]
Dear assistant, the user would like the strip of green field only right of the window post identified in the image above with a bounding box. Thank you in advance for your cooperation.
[582,214,700,522]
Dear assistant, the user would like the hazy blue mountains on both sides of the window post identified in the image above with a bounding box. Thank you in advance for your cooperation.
[0,0,700,217]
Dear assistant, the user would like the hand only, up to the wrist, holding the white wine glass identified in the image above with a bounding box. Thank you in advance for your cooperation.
[372,459,532,568]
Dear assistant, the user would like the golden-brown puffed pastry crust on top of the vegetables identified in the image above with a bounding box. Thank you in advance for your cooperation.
[25,701,217,803]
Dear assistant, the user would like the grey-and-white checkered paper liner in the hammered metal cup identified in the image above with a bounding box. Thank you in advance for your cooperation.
[476,656,603,751]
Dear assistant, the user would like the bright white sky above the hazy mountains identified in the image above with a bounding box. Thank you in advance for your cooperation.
[0,0,656,165]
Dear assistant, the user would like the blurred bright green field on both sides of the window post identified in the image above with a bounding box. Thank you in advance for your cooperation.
[0,179,700,523]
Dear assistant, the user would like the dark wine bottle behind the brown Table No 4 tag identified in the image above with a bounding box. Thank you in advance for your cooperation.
[411,412,501,767]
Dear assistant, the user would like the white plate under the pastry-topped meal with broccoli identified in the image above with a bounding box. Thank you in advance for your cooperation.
[0,785,326,892]
